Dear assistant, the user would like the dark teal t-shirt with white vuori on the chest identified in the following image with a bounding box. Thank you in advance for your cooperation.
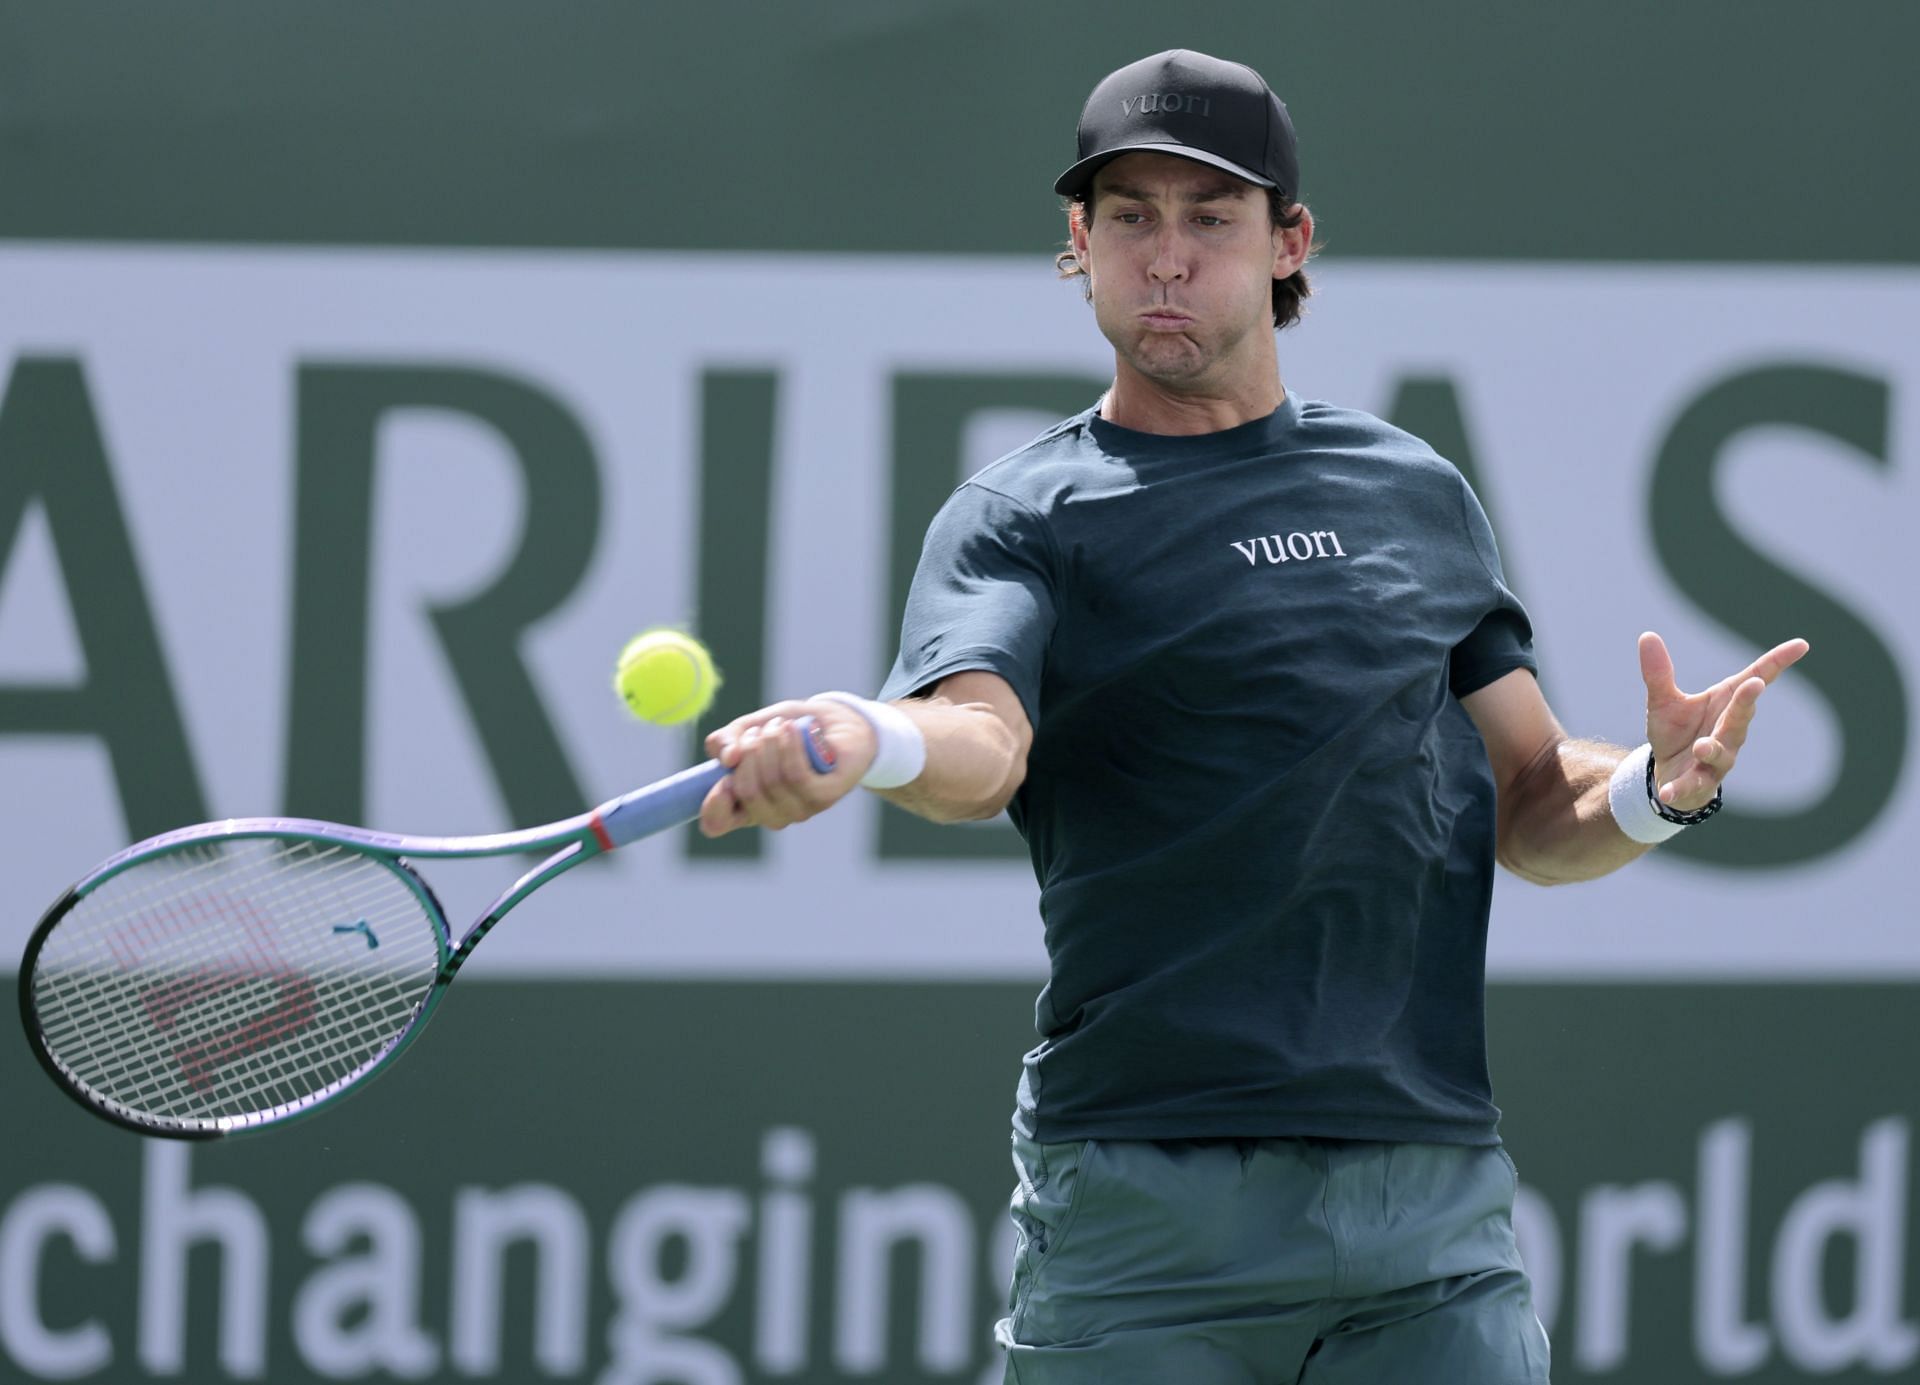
[881,396,1534,1145]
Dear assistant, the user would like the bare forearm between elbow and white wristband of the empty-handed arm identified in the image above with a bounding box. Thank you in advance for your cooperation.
[1500,740,1649,886]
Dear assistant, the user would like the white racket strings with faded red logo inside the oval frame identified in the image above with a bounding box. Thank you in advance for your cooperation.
[33,838,440,1126]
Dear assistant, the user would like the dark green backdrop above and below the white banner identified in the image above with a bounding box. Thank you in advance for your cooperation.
[0,0,1920,1385]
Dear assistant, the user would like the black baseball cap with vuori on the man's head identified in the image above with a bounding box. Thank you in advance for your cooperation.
[1054,48,1300,202]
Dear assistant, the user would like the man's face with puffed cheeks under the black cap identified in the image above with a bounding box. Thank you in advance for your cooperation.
[1073,154,1306,392]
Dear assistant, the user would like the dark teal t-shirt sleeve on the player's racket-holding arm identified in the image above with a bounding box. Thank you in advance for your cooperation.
[879,482,1056,726]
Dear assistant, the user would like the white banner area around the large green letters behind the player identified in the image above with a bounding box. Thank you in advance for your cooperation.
[0,244,1920,978]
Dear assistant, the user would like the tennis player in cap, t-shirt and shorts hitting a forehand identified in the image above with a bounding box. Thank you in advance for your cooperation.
[701,52,1807,1385]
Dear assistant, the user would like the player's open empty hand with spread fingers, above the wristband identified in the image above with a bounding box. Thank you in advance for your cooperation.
[1640,630,1811,813]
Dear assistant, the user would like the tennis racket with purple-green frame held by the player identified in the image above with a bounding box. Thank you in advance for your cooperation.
[19,717,833,1139]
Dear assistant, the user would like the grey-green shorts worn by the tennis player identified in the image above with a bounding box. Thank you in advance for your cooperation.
[996,1133,1548,1385]
